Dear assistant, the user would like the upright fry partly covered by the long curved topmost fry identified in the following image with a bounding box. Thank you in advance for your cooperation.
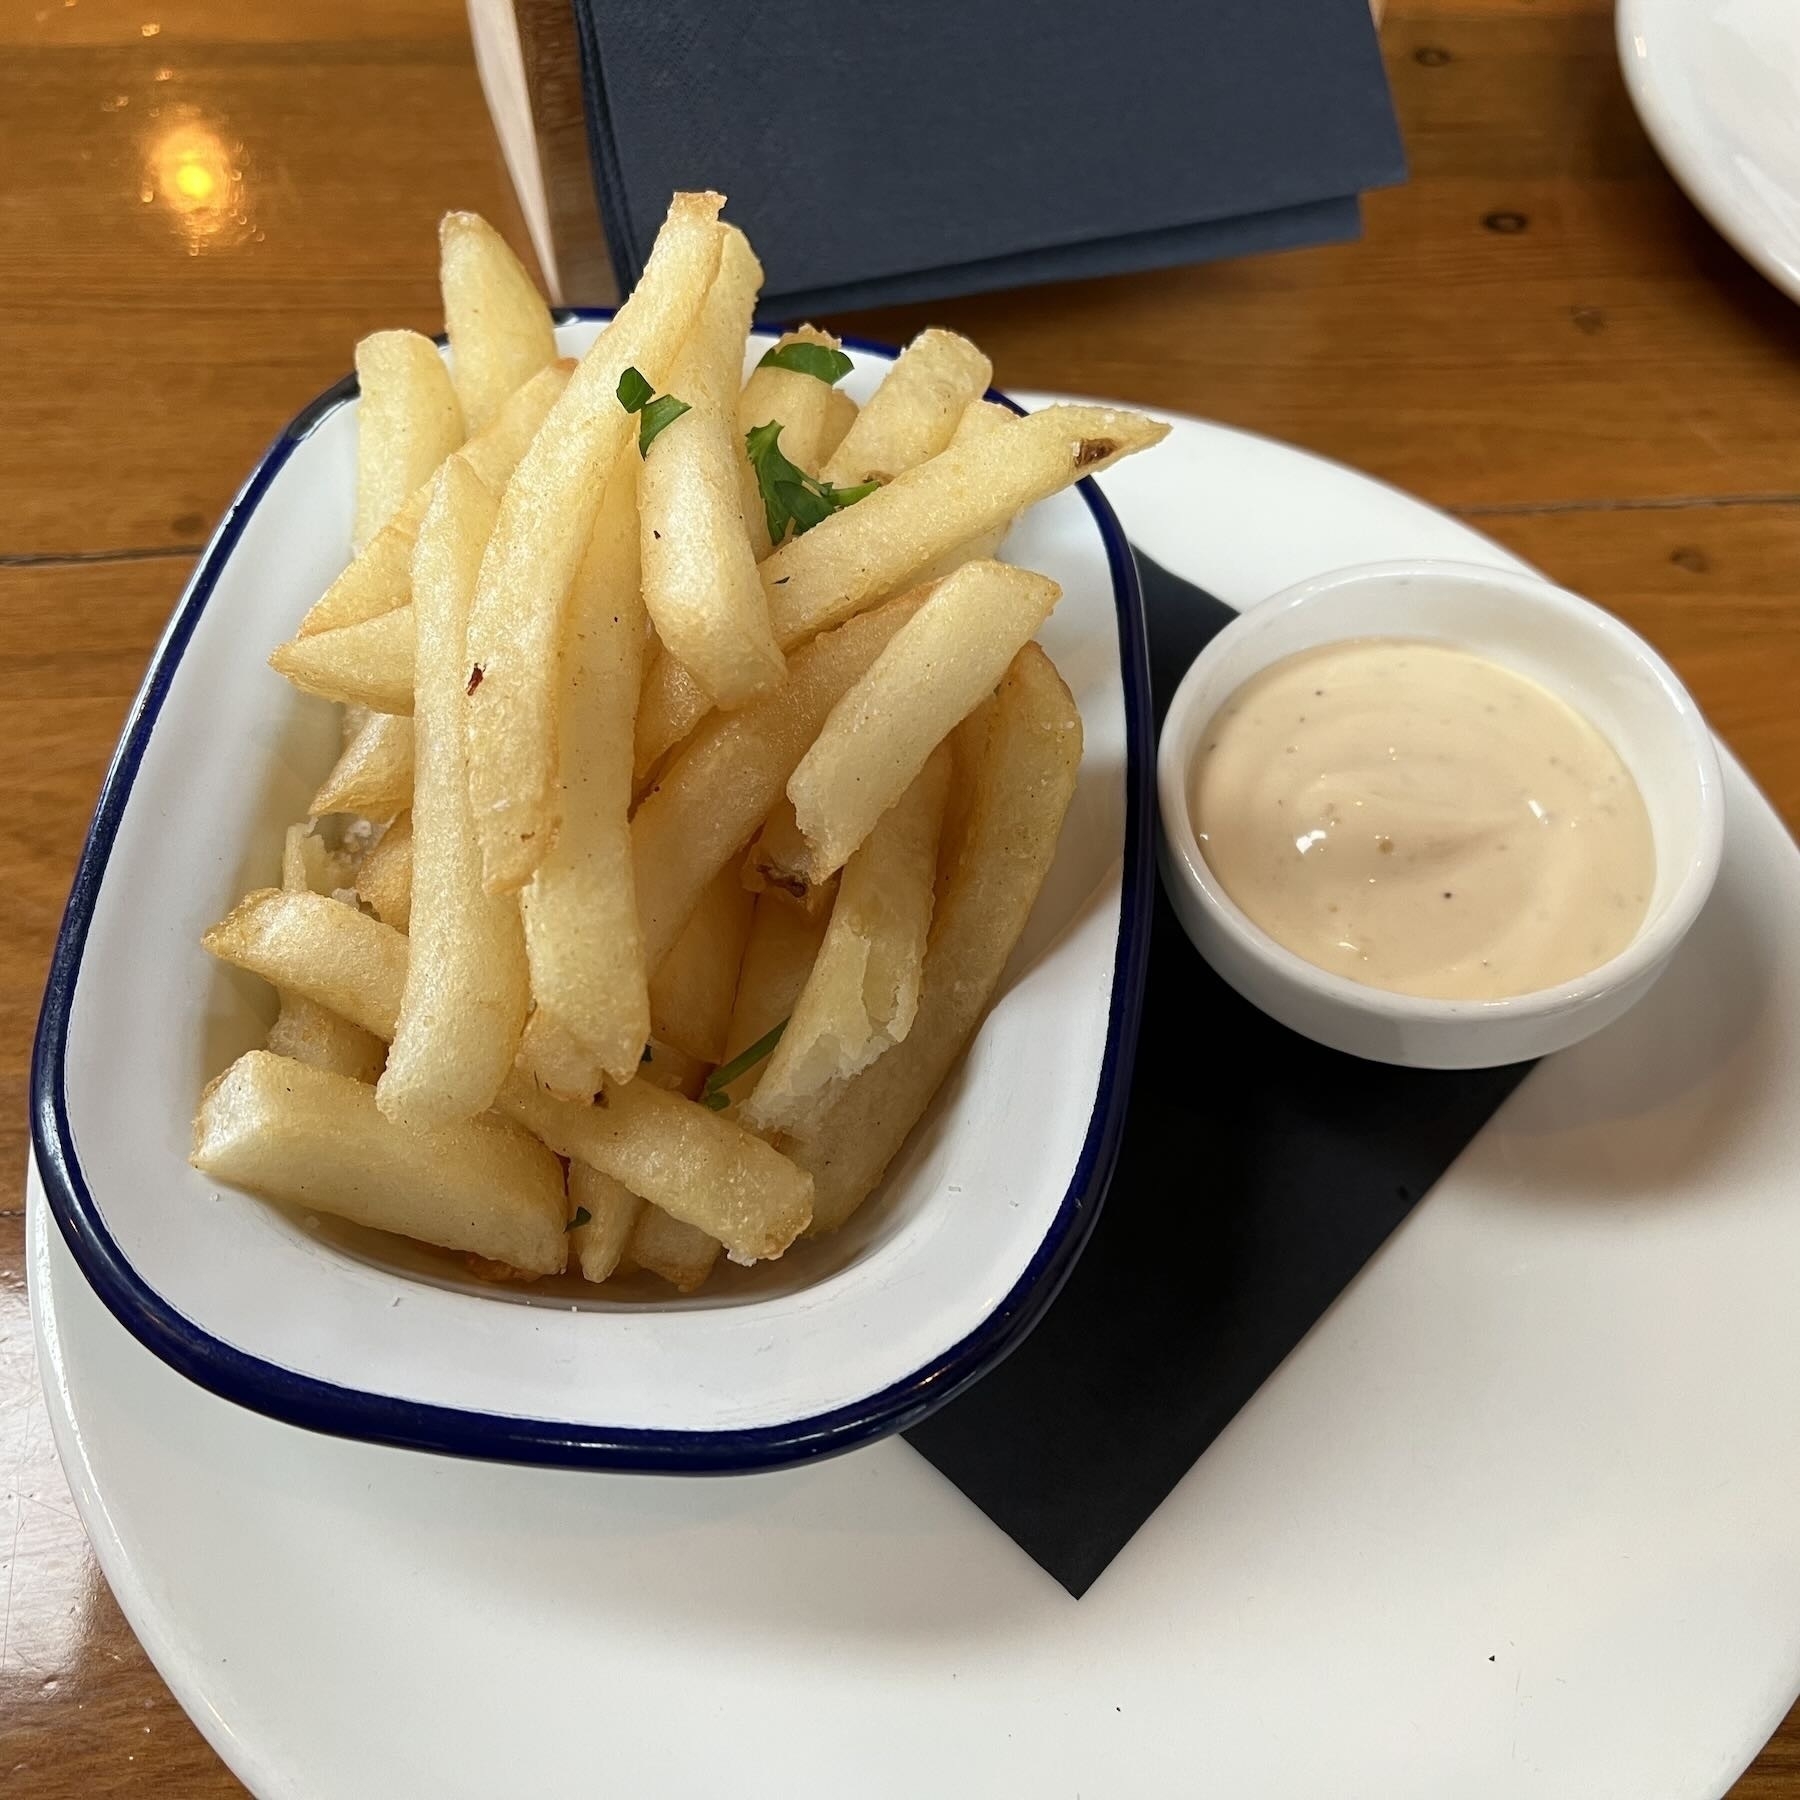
[518,459,650,1094]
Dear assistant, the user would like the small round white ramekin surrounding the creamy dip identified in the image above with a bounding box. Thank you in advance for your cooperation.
[1156,560,1724,1069]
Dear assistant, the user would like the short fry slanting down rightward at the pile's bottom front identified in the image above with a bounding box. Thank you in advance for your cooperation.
[500,1071,812,1262]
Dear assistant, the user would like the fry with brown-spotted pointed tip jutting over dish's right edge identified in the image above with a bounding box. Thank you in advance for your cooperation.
[761,405,1168,650]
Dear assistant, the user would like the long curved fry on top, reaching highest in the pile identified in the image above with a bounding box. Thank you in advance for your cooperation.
[466,194,724,893]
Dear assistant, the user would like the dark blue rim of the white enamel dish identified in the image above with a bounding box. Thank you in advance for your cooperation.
[31,308,1156,1474]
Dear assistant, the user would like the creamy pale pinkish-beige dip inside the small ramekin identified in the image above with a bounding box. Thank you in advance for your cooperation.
[1190,637,1656,999]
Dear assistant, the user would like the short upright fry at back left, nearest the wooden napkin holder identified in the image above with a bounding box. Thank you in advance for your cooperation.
[437,212,556,436]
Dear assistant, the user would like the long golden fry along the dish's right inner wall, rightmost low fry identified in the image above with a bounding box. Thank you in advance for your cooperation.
[787,644,1082,1231]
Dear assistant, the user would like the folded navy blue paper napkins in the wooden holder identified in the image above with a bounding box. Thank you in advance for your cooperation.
[574,0,1404,313]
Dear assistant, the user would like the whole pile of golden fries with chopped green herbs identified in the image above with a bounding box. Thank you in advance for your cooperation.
[193,193,1166,1291]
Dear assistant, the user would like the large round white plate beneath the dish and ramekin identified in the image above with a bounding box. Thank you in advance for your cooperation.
[29,408,1800,1800]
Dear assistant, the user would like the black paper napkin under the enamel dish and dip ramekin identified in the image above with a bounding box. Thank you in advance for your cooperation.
[907,554,1530,1597]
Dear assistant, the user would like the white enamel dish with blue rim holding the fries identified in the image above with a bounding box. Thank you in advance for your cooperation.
[24,317,1154,1471]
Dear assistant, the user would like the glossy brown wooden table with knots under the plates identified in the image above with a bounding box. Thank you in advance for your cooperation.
[0,0,1800,1800]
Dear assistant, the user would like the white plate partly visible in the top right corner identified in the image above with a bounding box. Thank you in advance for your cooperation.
[1615,0,1800,301]
